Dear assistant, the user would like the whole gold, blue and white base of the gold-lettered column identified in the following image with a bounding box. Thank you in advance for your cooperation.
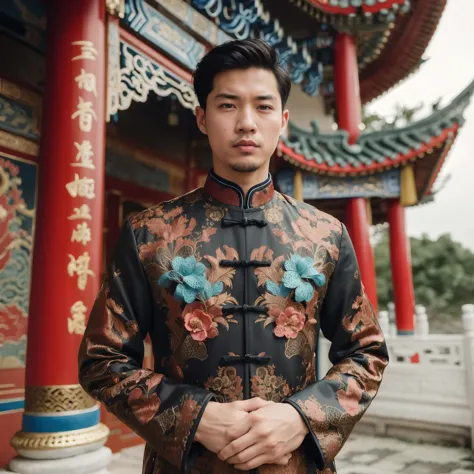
[9,384,111,474]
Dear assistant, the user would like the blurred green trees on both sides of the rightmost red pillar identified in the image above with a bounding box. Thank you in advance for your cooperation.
[374,230,474,332]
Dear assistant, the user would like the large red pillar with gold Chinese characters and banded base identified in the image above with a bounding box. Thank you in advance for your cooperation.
[12,0,107,458]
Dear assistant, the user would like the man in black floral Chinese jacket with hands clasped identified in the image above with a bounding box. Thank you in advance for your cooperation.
[80,40,388,474]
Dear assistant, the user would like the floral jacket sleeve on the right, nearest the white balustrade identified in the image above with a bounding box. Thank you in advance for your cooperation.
[285,225,388,469]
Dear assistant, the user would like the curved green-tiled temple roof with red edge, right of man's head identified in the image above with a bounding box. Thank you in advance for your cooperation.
[279,81,474,178]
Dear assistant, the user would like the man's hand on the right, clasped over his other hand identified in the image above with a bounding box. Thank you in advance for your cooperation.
[219,399,308,471]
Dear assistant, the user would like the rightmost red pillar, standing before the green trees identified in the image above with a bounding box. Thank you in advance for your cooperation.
[388,199,415,335]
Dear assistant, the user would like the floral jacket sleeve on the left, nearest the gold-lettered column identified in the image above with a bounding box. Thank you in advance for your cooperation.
[79,222,213,473]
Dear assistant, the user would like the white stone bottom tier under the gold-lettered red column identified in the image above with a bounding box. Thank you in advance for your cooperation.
[5,447,112,474]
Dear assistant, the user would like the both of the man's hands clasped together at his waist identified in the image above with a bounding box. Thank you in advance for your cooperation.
[195,398,308,470]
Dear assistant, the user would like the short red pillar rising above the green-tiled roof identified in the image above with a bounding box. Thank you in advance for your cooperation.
[334,33,362,143]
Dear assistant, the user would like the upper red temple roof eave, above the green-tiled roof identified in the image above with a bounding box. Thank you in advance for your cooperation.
[279,0,447,104]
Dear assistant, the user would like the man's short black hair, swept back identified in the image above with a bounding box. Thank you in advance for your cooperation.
[193,39,291,109]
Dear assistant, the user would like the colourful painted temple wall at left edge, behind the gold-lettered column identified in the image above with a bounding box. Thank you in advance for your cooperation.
[0,78,41,466]
